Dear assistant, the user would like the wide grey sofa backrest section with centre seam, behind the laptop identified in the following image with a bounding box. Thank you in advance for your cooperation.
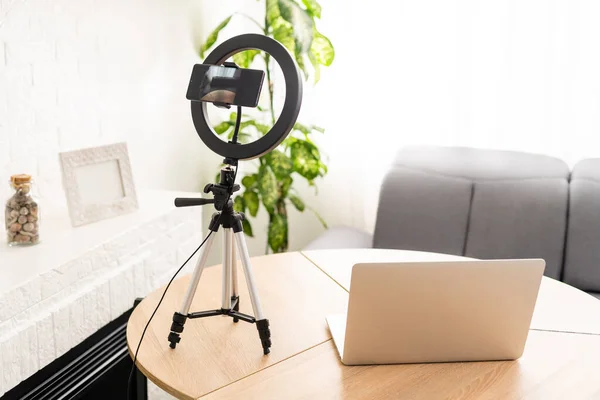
[373,146,569,278]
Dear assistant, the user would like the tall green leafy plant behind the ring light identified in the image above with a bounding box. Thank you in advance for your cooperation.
[199,0,335,253]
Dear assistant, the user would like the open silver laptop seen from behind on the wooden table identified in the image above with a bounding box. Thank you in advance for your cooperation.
[327,259,546,365]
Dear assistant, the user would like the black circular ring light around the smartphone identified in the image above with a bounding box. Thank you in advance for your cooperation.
[191,33,302,160]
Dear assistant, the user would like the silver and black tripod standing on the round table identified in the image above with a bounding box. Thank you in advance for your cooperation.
[168,164,271,354]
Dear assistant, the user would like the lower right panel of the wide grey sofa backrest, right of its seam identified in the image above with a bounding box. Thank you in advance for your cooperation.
[464,179,569,279]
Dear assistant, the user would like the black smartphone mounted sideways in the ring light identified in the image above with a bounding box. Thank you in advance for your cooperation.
[185,64,265,107]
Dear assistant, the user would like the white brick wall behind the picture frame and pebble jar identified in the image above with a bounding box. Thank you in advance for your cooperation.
[0,0,203,209]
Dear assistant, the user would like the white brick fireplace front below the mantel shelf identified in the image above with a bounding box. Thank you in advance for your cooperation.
[0,200,203,398]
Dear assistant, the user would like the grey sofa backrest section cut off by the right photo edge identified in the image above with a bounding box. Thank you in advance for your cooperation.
[563,159,600,292]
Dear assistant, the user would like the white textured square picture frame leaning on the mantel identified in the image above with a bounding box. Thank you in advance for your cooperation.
[59,143,138,226]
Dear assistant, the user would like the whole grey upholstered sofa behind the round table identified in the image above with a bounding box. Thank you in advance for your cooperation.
[306,147,600,298]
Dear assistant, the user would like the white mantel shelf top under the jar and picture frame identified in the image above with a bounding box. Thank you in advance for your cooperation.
[0,191,200,293]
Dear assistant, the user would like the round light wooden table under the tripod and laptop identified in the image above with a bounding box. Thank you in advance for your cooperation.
[127,250,600,400]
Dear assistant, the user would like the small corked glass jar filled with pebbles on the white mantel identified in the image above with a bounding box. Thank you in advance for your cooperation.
[5,174,40,246]
